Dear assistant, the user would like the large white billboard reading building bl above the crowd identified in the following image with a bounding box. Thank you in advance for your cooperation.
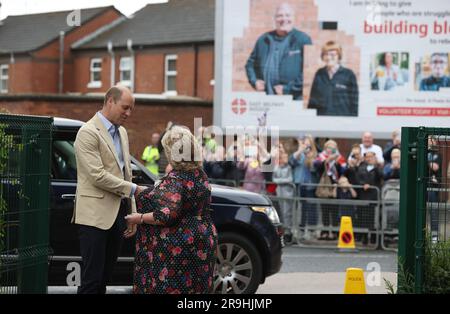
[214,0,450,137]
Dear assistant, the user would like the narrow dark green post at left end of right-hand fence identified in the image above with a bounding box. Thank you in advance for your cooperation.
[397,127,418,292]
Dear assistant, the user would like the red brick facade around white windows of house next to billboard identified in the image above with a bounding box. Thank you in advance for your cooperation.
[73,44,214,100]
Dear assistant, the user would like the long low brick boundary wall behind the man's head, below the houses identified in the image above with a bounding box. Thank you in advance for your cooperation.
[0,98,213,159]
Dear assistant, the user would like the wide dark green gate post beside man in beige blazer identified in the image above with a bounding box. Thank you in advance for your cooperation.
[17,118,53,293]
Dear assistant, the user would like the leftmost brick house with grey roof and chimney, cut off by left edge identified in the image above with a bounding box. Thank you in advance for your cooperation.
[0,6,123,94]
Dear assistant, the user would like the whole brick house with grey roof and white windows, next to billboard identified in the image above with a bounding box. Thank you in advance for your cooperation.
[72,0,214,101]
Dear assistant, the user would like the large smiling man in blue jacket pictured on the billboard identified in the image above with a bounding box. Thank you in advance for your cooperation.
[245,3,312,100]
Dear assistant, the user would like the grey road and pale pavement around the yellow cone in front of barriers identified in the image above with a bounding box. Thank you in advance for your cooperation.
[257,246,397,294]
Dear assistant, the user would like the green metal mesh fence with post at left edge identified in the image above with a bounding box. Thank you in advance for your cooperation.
[0,114,53,294]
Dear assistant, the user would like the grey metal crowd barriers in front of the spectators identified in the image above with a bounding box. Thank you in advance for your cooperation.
[206,179,400,250]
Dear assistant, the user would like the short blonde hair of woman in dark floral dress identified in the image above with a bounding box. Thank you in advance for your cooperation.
[161,125,202,170]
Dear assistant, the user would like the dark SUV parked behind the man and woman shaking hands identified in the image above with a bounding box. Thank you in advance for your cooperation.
[48,118,282,294]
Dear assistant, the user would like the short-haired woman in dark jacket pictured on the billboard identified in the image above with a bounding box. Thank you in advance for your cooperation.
[308,41,358,116]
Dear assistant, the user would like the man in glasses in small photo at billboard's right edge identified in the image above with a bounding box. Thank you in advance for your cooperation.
[420,53,450,91]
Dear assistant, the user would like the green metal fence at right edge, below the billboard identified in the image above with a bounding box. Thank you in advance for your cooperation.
[398,127,450,293]
